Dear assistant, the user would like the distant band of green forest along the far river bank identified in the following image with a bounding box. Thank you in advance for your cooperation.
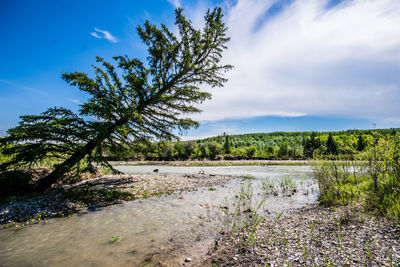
[107,128,399,160]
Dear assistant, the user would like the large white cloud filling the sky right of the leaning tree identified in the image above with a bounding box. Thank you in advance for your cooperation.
[190,0,400,121]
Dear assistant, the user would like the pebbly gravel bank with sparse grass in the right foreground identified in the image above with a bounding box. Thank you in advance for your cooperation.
[203,204,400,266]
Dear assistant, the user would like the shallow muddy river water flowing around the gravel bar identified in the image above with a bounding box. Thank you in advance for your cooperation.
[0,166,317,266]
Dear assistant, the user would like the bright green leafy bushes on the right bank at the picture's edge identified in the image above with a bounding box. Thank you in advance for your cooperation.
[314,134,400,220]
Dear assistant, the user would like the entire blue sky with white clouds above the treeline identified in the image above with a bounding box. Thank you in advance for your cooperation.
[0,0,400,139]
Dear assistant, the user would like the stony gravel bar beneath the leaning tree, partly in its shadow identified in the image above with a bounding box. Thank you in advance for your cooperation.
[0,174,233,230]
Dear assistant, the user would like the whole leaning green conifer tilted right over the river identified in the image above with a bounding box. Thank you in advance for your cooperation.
[0,8,232,191]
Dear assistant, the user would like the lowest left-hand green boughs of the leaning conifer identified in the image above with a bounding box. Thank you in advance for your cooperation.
[0,108,91,171]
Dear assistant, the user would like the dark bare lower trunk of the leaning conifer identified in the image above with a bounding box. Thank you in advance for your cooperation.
[36,123,121,192]
